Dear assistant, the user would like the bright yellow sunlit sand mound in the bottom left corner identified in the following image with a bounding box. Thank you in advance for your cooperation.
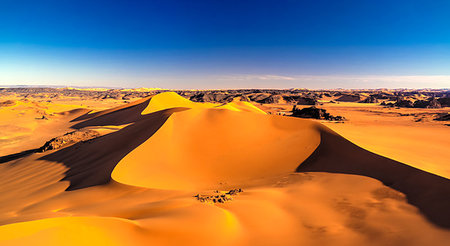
[0,217,146,246]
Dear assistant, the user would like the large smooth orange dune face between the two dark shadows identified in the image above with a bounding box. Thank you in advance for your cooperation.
[112,109,320,189]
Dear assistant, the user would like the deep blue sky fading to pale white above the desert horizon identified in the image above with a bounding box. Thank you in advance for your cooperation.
[0,0,450,88]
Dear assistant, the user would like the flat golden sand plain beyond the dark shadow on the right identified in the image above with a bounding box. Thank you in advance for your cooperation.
[318,103,450,178]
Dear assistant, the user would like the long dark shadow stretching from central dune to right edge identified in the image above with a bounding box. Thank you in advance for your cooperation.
[296,128,450,228]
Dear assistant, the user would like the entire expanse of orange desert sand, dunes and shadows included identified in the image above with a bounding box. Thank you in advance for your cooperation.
[0,92,450,245]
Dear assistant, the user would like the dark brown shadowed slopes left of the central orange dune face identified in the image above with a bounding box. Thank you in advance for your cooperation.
[40,105,186,190]
